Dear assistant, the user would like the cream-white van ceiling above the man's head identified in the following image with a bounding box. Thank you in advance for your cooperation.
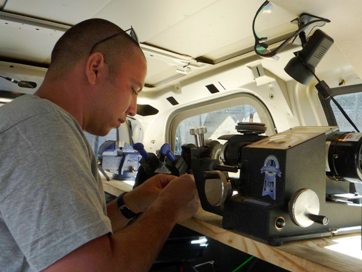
[0,0,362,94]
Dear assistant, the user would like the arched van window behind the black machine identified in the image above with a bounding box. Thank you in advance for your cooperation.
[174,95,275,155]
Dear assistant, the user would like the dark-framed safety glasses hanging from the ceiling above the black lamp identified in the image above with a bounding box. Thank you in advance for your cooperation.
[252,1,330,57]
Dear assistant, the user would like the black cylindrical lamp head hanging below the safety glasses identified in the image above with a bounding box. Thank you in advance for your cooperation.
[284,29,334,84]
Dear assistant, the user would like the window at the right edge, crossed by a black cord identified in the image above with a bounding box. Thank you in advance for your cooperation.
[331,92,362,131]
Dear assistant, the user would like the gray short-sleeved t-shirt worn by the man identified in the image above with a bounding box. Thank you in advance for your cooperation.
[0,95,112,272]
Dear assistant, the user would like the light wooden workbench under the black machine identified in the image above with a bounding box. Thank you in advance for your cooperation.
[103,181,362,272]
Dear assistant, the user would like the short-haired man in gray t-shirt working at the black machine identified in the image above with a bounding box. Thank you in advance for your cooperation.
[0,19,197,272]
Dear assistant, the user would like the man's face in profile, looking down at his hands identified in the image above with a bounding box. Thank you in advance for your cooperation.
[88,48,147,136]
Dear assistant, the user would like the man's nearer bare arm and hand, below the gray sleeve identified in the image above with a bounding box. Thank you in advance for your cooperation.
[46,175,198,272]
